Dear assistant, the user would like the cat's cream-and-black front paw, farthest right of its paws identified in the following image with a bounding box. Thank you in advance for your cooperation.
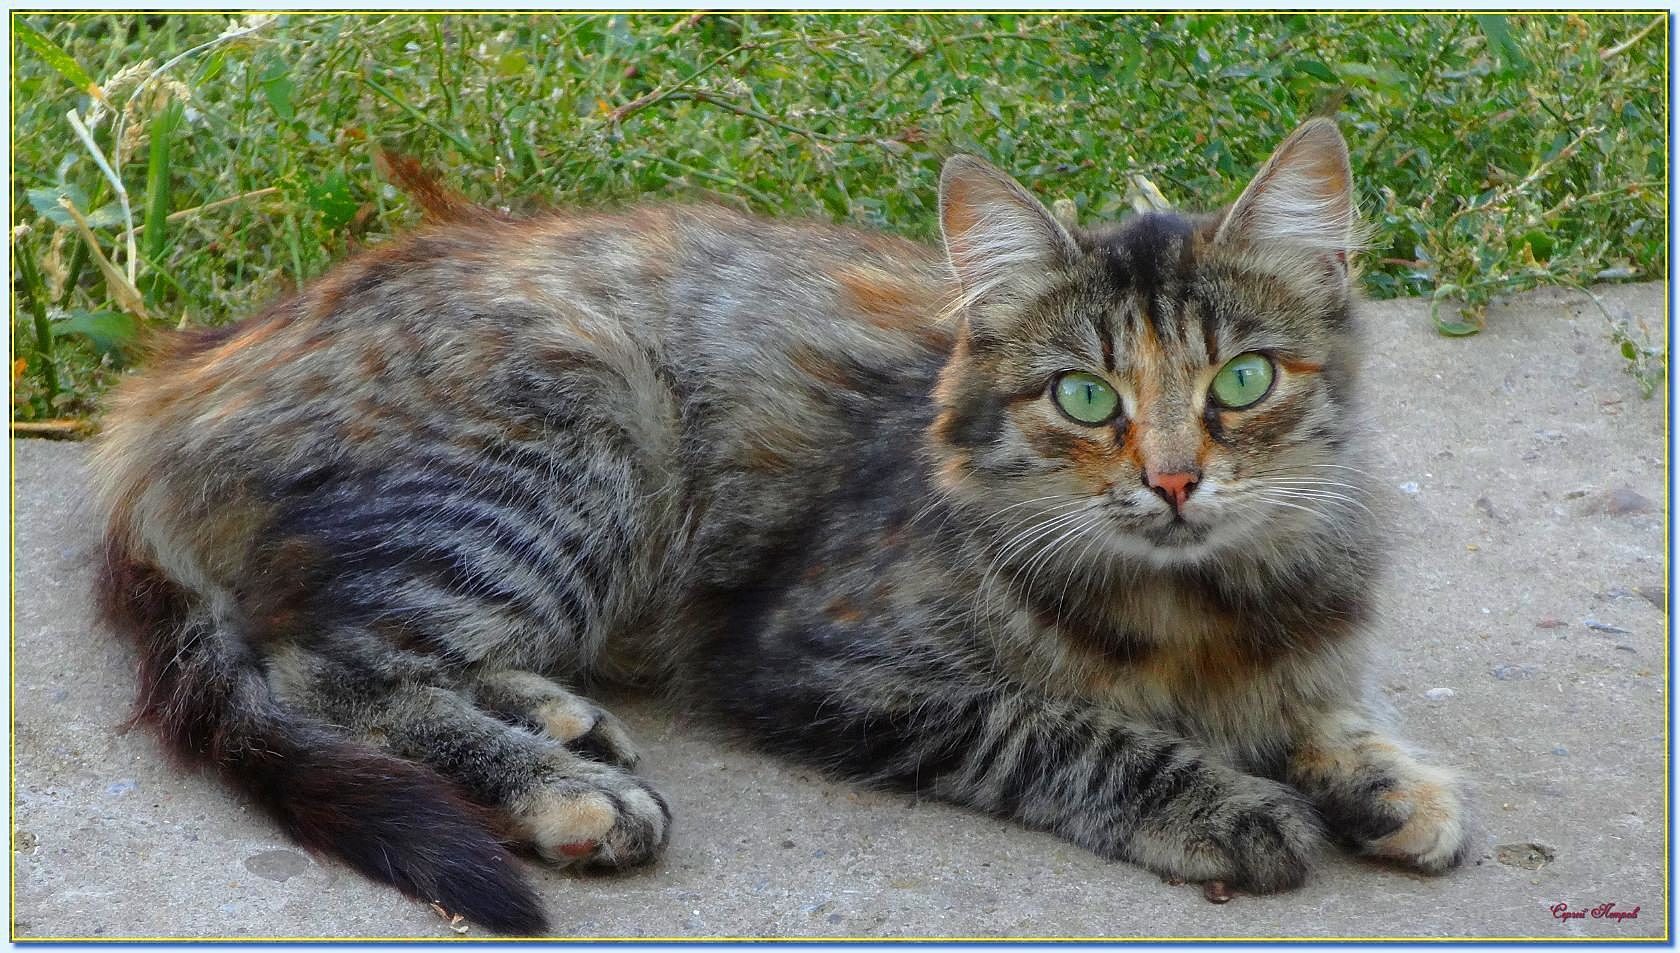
[1287,709,1470,874]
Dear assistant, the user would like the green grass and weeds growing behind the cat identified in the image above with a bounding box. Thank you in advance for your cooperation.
[12,13,1667,420]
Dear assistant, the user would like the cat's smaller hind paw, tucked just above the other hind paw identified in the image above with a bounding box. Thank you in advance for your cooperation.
[467,669,642,768]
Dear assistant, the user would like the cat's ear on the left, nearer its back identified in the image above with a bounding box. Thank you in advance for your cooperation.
[939,155,1079,321]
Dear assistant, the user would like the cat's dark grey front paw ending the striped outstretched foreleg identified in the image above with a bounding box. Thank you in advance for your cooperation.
[1131,771,1324,894]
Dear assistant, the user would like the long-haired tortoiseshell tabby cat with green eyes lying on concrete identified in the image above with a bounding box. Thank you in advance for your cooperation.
[96,119,1470,935]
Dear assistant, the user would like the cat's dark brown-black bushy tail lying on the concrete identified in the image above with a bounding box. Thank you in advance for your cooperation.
[99,534,546,936]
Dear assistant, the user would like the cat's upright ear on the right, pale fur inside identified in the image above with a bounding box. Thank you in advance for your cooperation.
[1213,118,1361,269]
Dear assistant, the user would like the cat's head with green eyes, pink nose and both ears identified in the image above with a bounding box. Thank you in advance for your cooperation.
[931,119,1362,565]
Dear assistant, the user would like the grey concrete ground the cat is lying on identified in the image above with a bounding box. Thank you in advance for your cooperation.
[12,286,1668,938]
